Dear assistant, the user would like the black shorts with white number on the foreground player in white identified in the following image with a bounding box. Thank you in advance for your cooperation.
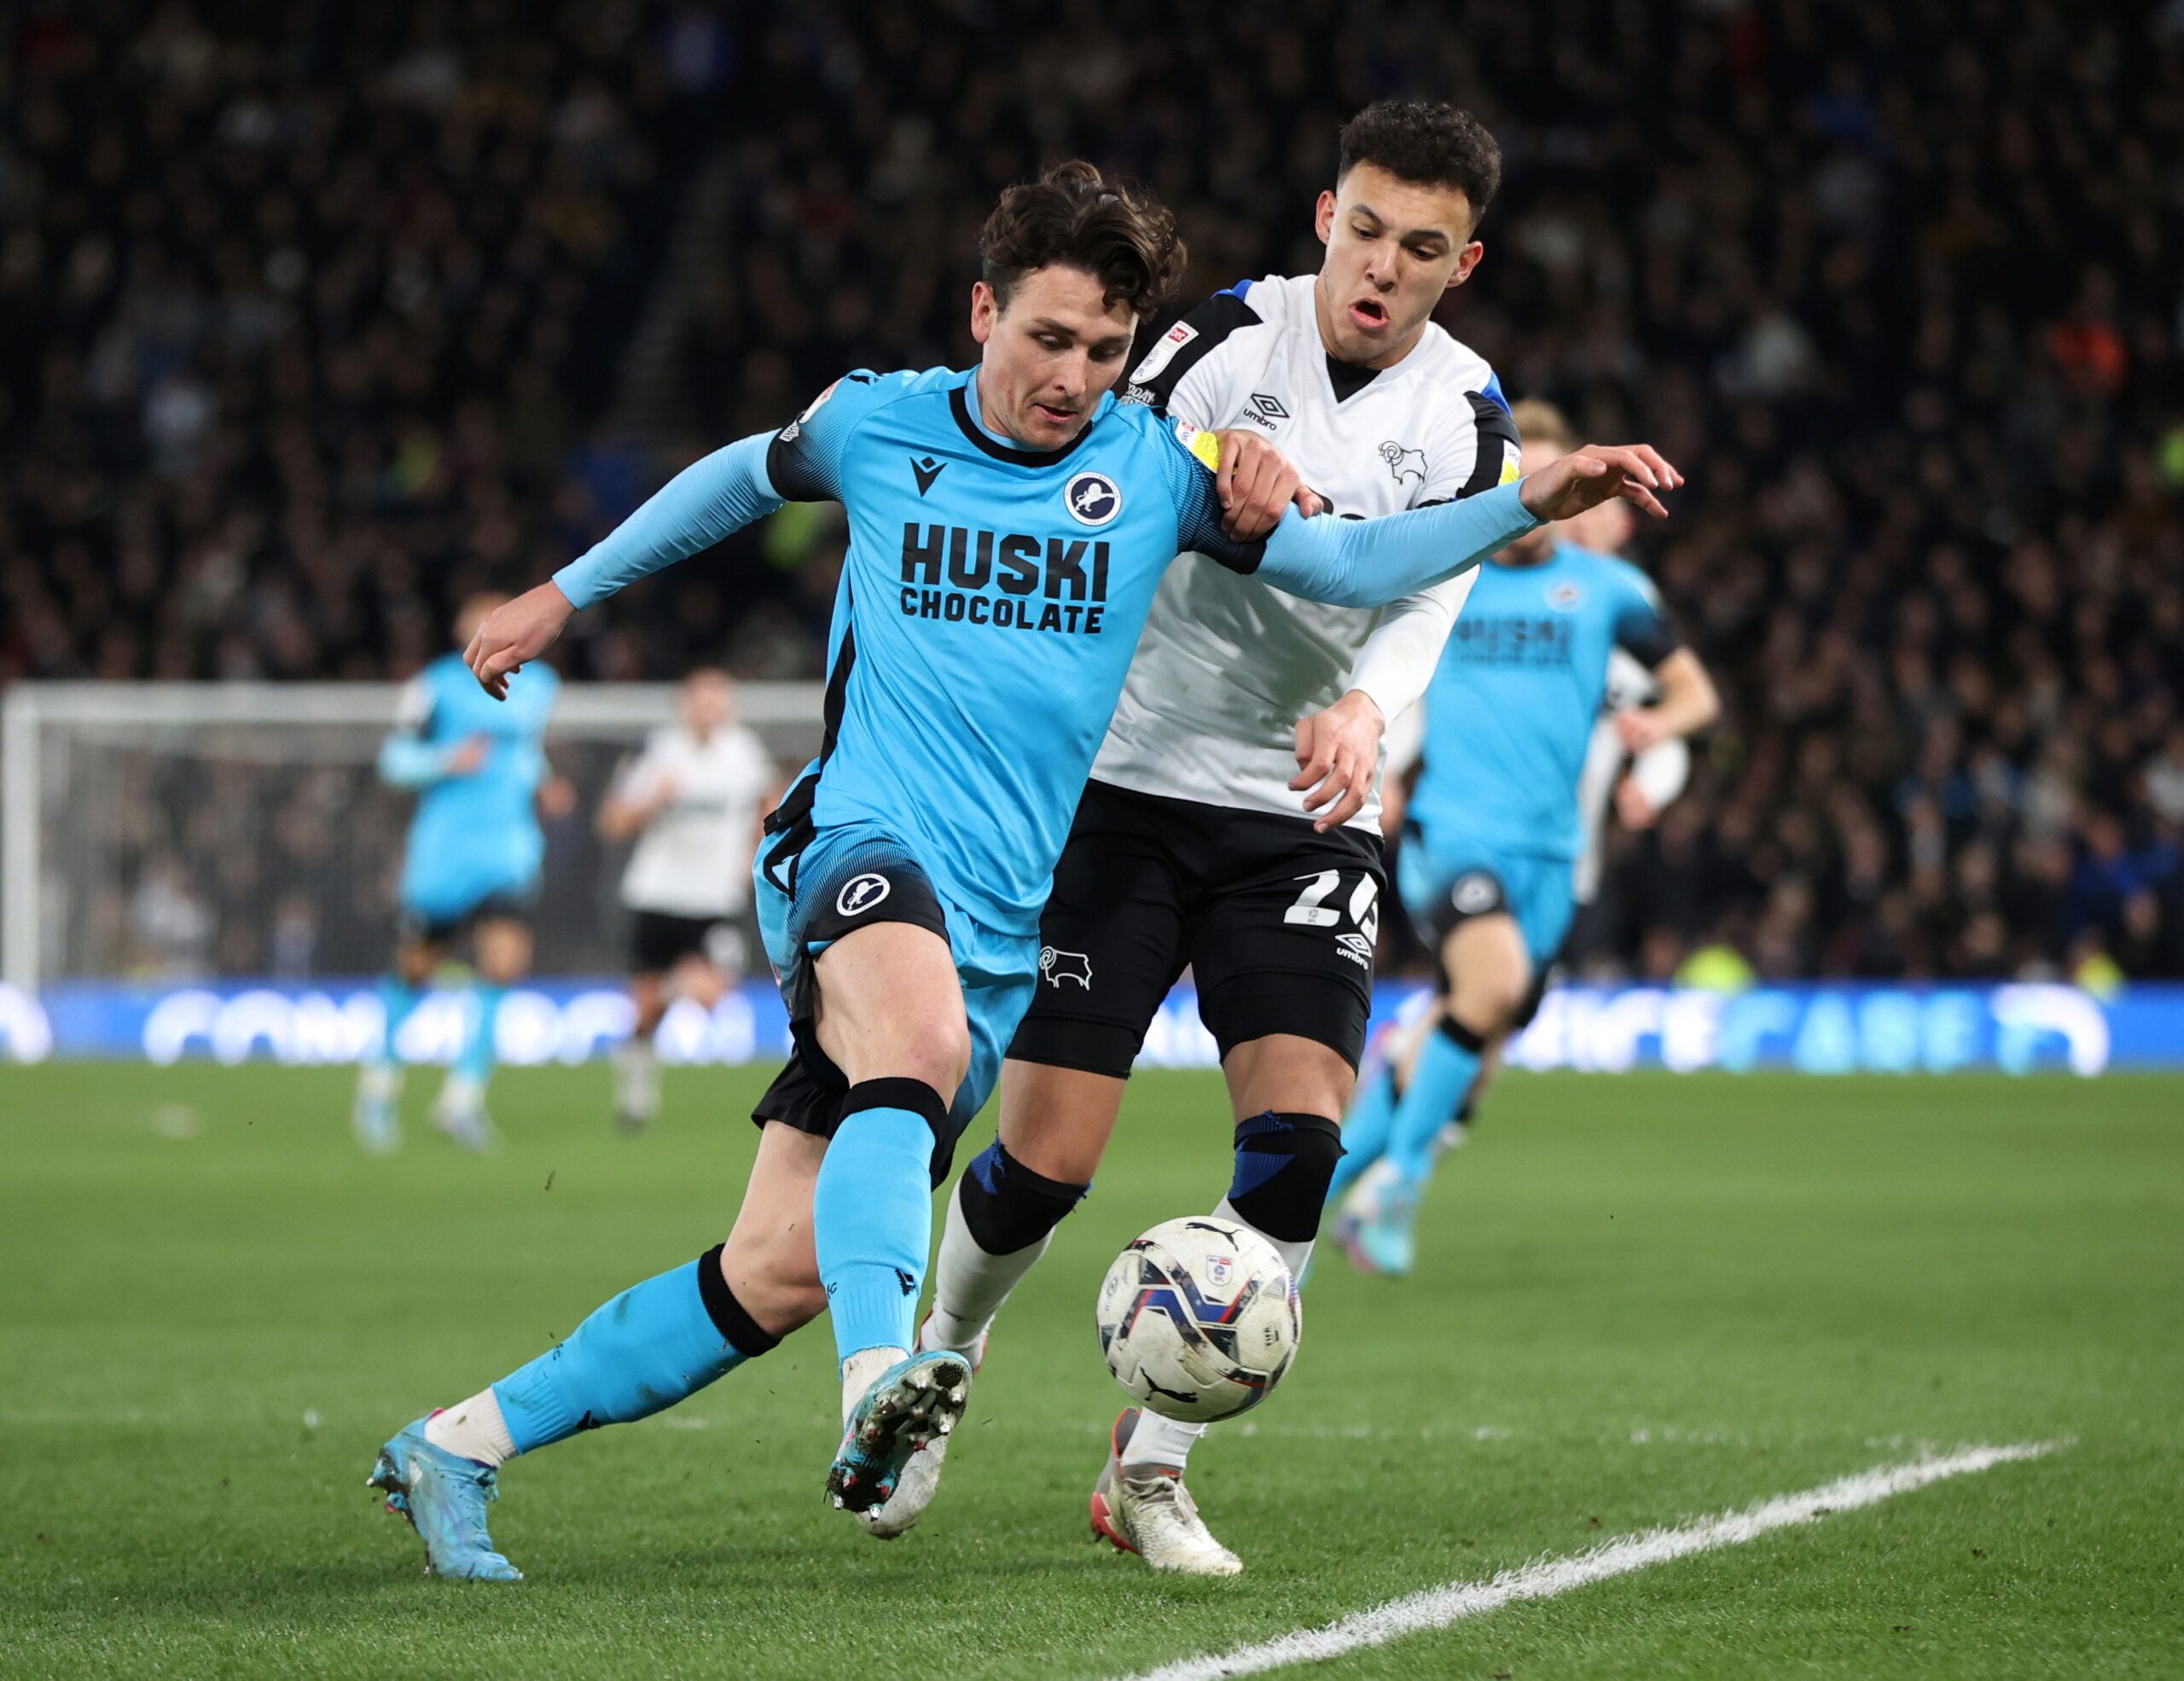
[1009,782,1387,1079]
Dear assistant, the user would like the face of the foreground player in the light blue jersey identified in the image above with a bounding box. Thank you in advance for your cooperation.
[970,262,1138,450]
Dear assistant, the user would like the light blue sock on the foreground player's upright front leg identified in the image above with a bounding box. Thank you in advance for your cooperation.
[812,1080,939,1360]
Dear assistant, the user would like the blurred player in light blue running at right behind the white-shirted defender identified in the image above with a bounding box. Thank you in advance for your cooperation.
[1333,402,1721,1273]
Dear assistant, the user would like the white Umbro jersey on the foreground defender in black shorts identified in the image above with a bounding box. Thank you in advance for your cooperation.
[1092,275,1518,828]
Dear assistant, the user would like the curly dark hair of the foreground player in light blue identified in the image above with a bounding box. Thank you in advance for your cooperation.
[979,157,1188,317]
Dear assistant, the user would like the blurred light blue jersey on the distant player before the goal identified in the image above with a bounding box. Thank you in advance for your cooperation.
[380,653,561,922]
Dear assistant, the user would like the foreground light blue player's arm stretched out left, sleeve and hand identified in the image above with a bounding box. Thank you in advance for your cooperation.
[463,433,781,701]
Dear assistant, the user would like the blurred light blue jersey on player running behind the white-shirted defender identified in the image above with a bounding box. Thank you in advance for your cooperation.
[1409,544,1677,875]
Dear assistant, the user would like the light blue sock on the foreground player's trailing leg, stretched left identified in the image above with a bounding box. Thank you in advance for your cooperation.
[494,1248,775,1454]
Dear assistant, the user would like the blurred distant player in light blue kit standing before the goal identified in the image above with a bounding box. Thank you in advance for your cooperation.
[354,596,566,1155]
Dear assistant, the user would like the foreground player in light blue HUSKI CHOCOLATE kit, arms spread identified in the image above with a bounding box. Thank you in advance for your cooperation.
[371,164,1680,1580]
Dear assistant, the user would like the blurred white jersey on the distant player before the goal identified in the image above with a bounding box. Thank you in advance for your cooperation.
[613,724,773,917]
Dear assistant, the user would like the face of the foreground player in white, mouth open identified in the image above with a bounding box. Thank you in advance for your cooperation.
[1317,164,1485,367]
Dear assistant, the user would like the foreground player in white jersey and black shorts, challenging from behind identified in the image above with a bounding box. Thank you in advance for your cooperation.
[867,101,1518,1576]
